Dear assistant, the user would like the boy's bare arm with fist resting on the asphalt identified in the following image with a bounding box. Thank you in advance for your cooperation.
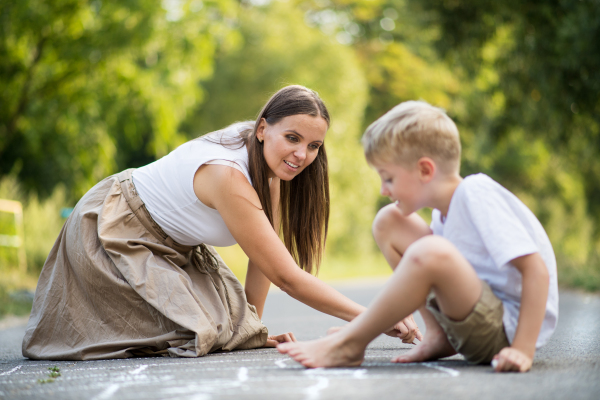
[495,253,550,372]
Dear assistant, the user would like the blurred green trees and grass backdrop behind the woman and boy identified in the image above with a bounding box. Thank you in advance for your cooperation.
[0,0,600,316]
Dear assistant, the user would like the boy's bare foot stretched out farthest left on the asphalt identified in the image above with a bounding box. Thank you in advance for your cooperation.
[277,334,365,368]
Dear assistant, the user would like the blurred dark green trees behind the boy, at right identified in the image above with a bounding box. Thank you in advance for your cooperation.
[297,0,600,290]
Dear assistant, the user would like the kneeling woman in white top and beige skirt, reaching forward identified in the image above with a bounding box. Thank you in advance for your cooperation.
[23,86,416,360]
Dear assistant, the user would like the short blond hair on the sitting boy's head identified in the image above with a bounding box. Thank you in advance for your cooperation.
[362,101,460,173]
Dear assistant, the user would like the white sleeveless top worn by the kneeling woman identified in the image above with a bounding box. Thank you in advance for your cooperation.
[133,122,253,247]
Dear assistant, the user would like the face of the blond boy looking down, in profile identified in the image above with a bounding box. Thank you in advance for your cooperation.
[373,163,424,216]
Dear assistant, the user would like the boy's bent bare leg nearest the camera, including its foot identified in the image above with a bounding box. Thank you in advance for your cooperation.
[277,236,481,368]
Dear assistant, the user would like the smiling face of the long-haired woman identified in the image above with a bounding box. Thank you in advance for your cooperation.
[256,114,328,181]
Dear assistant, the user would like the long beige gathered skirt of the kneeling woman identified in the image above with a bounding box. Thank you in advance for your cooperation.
[23,170,267,360]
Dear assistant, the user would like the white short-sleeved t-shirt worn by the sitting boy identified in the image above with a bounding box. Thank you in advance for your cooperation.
[431,174,558,348]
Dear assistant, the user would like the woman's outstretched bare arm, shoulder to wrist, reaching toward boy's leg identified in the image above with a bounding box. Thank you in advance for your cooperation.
[194,165,365,321]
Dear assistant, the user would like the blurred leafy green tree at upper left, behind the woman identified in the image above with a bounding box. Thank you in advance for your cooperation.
[0,0,238,198]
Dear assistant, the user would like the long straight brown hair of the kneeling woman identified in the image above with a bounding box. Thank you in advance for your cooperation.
[240,85,330,273]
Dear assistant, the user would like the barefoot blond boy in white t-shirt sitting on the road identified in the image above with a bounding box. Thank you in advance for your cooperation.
[277,101,558,372]
